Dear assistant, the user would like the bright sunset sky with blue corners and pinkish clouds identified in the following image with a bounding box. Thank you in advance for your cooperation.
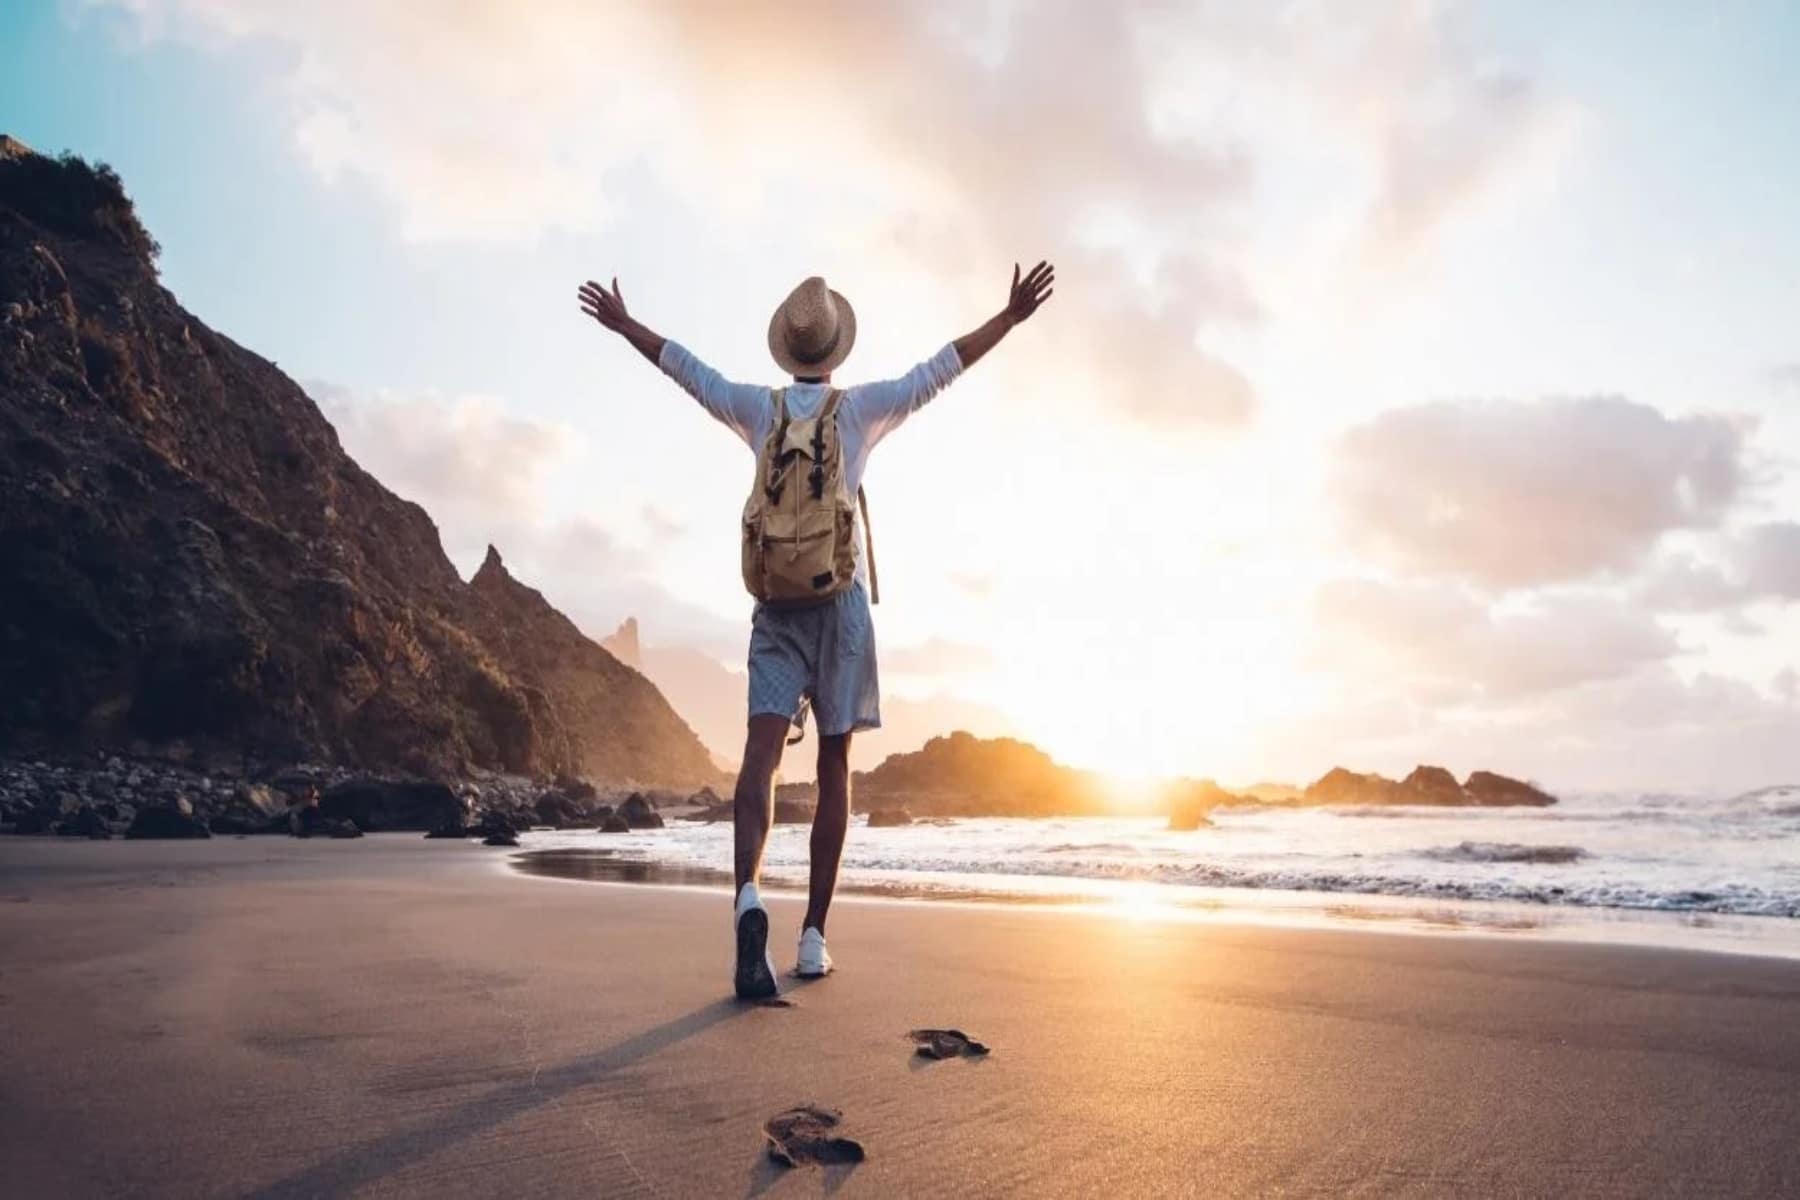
[0,0,1800,792]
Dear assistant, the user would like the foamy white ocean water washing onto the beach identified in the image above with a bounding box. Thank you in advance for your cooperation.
[526,786,1800,954]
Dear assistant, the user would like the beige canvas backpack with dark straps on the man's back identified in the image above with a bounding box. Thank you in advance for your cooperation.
[743,389,880,608]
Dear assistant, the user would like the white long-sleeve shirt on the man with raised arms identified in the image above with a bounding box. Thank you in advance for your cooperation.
[657,342,963,587]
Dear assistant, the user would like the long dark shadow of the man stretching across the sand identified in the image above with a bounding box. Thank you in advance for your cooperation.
[250,999,748,1200]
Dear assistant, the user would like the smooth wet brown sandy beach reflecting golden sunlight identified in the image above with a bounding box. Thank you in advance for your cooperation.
[0,835,1800,1196]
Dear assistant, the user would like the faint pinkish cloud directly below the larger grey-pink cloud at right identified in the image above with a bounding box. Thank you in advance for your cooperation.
[1312,579,1678,705]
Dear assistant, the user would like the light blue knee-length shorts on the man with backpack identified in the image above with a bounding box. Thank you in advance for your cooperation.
[751,579,882,738]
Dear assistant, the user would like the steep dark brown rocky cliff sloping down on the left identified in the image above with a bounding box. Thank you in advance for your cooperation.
[0,139,716,786]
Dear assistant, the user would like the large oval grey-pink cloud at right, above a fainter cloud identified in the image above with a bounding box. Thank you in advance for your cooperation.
[1330,396,1750,588]
